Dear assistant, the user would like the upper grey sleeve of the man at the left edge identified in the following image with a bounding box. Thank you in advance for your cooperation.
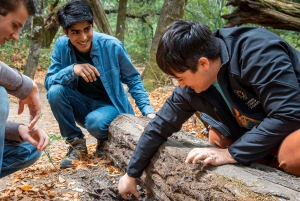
[0,61,33,100]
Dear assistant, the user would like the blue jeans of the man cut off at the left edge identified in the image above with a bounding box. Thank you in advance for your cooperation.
[0,86,41,178]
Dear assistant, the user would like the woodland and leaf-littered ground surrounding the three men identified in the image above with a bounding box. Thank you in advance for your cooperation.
[0,0,300,200]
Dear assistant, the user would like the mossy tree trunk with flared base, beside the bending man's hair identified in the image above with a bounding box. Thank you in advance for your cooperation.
[142,0,186,91]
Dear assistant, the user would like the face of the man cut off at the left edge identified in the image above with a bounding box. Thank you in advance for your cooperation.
[0,4,28,45]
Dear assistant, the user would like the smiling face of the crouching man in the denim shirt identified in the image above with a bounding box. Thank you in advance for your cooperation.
[63,22,93,53]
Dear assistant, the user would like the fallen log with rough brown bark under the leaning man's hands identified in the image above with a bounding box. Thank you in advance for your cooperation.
[104,114,300,201]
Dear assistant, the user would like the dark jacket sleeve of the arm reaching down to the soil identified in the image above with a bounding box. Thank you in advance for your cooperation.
[127,87,195,178]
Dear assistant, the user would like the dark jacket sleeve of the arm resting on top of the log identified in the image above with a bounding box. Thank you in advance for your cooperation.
[229,32,300,165]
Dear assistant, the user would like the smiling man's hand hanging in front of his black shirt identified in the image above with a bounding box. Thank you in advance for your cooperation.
[73,63,100,82]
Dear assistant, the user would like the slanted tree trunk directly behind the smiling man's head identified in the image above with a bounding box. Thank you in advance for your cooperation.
[83,0,113,35]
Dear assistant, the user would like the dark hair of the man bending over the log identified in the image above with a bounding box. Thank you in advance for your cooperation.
[156,20,221,75]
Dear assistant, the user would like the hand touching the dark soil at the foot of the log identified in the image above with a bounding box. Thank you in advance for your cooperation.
[118,173,142,200]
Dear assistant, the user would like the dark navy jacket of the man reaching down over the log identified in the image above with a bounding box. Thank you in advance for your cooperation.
[127,27,300,178]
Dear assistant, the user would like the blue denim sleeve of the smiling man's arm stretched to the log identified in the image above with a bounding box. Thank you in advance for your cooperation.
[118,43,155,116]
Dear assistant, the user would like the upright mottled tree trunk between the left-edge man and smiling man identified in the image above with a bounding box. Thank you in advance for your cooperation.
[24,0,44,79]
